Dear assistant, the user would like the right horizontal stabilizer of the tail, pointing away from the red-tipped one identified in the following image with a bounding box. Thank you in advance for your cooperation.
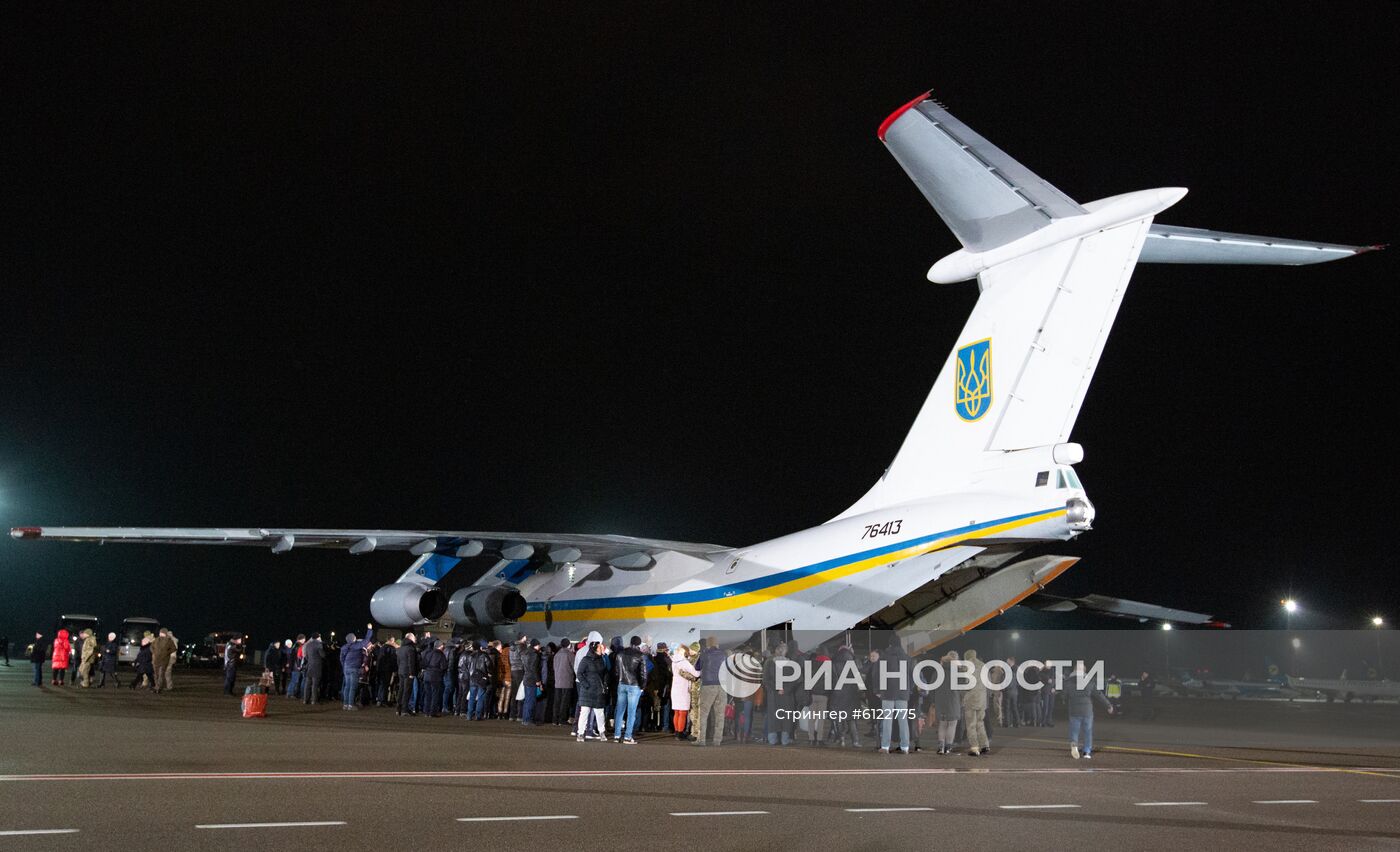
[1138,225,1383,266]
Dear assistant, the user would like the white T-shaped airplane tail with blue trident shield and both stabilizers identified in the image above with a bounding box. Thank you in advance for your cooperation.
[839,95,1366,518]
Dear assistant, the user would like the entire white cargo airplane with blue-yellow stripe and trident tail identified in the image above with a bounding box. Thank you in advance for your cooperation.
[11,94,1375,645]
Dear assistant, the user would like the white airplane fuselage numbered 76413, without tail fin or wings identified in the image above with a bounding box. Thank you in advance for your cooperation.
[496,471,1088,646]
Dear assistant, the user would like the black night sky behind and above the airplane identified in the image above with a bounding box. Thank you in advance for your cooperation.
[0,3,1400,637]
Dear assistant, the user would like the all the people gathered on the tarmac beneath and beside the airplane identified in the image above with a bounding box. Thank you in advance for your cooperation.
[19,624,1114,758]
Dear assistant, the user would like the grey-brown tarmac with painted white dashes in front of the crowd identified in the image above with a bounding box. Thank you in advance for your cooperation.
[0,662,1400,851]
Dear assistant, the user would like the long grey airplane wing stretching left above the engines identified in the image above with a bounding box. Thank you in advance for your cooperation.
[10,526,729,568]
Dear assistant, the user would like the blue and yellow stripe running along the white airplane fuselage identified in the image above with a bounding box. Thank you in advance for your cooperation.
[521,506,1064,621]
